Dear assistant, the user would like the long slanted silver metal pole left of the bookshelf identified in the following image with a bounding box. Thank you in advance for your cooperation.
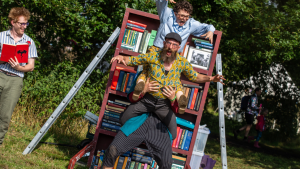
[23,27,120,155]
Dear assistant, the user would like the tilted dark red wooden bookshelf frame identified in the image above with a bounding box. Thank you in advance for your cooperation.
[88,8,222,169]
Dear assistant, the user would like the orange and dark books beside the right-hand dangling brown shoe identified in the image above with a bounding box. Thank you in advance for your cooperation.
[182,84,203,111]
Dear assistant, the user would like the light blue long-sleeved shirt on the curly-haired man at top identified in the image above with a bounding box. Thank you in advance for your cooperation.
[154,0,216,53]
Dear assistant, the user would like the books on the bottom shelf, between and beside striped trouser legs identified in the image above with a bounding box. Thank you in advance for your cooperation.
[90,147,186,169]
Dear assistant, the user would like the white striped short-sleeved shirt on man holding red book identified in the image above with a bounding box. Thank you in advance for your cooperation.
[0,30,38,78]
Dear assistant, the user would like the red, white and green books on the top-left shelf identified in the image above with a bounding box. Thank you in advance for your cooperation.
[121,20,157,53]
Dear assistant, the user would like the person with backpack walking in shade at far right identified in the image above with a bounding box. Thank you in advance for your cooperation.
[233,87,261,140]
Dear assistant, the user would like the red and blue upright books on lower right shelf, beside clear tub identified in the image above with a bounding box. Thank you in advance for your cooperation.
[172,126,193,151]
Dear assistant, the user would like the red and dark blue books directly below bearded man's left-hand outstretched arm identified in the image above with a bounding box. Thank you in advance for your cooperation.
[110,66,136,93]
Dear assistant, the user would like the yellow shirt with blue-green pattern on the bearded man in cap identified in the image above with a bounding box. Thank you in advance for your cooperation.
[127,51,197,99]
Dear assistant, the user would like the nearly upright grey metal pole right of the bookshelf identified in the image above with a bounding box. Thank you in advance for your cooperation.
[216,54,227,169]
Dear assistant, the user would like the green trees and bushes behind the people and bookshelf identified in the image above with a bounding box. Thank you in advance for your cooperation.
[0,0,300,137]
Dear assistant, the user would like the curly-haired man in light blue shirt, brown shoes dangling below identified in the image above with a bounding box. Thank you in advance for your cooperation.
[133,0,215,114]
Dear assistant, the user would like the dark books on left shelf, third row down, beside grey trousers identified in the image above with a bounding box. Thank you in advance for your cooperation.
[101,99,130,132]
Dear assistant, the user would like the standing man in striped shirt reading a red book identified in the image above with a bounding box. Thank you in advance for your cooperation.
[0,7,37,145]
